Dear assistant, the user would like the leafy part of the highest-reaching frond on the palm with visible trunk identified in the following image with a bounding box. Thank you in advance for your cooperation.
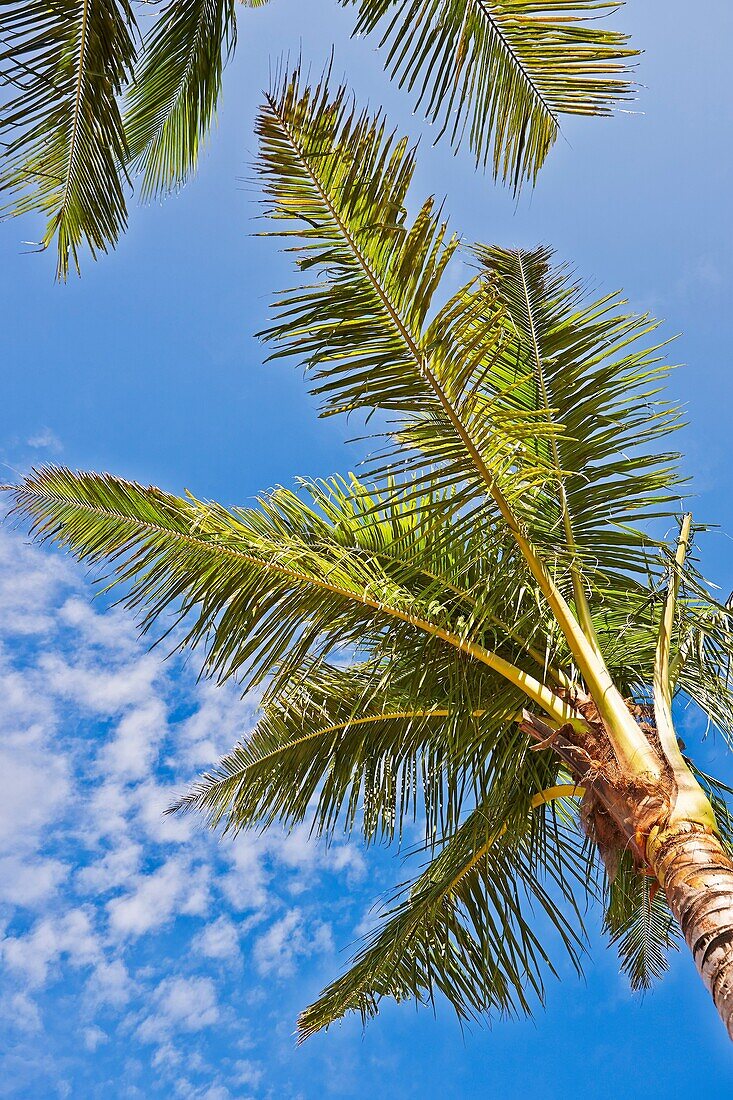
[258,73,554,523]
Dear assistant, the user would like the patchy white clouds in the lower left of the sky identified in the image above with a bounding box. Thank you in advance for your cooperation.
[0,528,362,1100]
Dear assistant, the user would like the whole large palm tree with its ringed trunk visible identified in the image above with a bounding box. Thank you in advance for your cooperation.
[5,73,733,1036]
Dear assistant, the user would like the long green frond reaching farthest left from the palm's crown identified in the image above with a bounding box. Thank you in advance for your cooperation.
[5,468,578,722]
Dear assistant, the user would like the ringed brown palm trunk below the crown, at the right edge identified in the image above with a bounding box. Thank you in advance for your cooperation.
[648,822,733,1040]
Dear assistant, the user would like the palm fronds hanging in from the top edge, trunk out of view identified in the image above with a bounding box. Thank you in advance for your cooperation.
[0,0,636,278]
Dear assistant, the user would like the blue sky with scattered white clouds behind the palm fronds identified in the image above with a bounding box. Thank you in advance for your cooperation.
[0,0,733,1100]
